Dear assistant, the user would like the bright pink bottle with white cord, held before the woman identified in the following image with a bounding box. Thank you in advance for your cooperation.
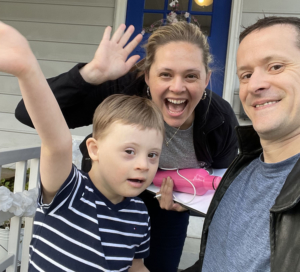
[153,168,222,195]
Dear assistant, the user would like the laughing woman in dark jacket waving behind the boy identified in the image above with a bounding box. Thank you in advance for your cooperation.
[16,22,238,272]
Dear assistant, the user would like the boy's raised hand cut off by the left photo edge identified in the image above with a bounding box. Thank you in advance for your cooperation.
[0,22,37,78]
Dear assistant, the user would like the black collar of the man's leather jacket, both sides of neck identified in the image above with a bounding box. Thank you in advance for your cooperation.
[236,126,300,212]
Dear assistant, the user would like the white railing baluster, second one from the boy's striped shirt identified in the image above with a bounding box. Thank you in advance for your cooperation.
[6,161,27,272]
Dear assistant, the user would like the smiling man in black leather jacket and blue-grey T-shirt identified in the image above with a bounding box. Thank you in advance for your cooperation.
[185,17,300,272]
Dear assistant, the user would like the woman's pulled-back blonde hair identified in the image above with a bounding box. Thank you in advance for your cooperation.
[141,21,212,73]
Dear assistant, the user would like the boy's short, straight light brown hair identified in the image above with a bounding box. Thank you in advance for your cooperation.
[93,94,165,139]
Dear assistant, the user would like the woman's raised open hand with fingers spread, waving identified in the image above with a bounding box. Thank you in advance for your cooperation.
[80,24,143,85]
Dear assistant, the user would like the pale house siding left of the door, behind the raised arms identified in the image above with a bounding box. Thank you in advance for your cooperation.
[0,0,127,149]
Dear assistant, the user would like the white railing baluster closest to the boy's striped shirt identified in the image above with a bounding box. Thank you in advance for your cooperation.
[21,159,40,272]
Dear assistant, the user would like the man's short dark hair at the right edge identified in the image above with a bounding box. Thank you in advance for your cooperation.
[239,16,300,48]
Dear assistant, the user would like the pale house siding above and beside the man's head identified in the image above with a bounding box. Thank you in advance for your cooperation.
[227,0,300,125]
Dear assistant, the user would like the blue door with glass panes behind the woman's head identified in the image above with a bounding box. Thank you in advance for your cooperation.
[126,0,231,96]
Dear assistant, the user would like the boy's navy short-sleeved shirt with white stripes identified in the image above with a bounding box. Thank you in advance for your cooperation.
[29,166,150,272]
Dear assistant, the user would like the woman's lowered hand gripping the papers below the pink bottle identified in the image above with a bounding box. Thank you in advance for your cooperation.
[157,177,187,212]
